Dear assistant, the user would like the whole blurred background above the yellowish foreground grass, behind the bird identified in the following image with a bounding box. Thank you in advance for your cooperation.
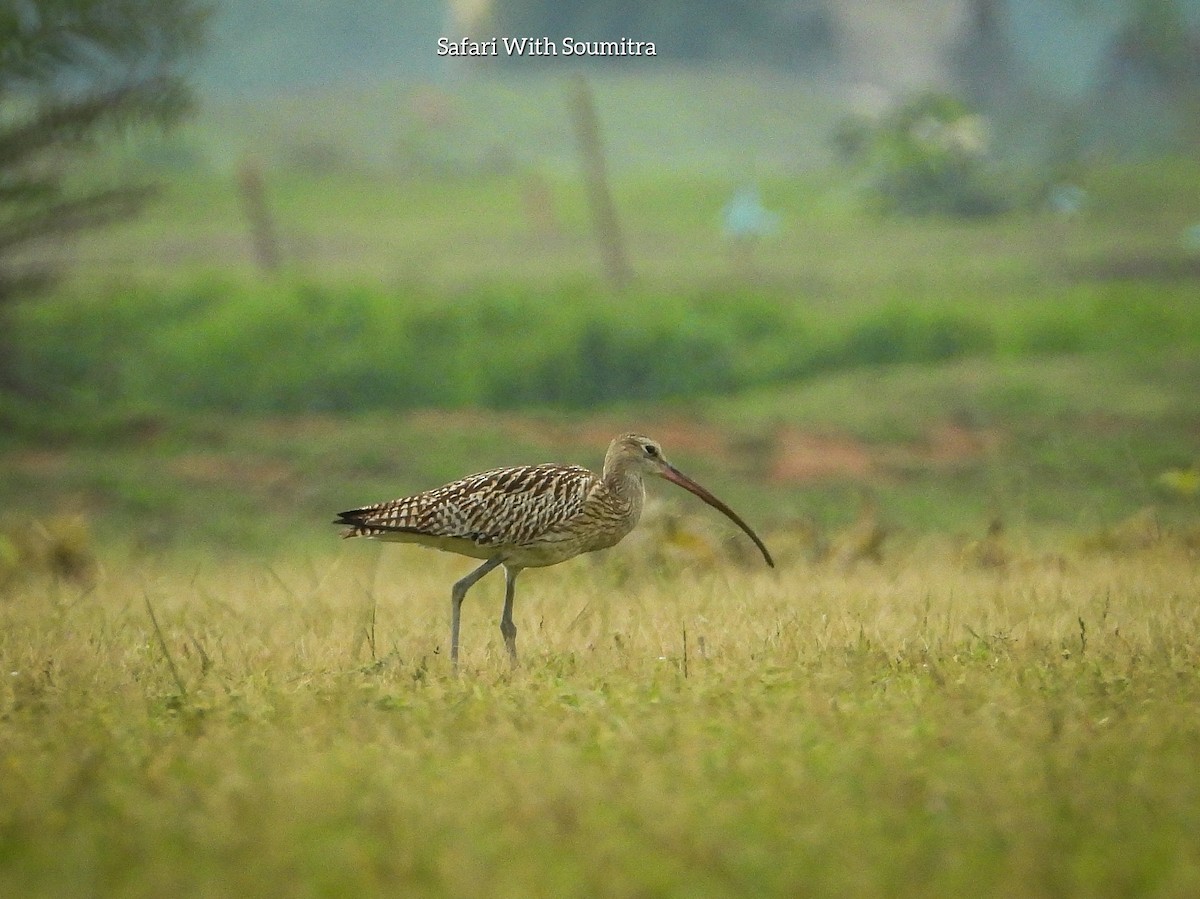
[0,0,1200,567]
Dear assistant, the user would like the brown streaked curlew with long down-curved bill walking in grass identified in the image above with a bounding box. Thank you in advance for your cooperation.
[334,433,775,669]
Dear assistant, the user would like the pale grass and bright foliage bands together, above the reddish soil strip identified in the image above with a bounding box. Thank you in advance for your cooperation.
[8,148,1200,413]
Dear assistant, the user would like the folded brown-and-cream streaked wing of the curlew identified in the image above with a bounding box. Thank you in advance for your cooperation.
[335,465,598,546]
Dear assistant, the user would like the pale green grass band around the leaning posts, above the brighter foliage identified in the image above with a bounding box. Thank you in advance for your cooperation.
[76,148,1200,288]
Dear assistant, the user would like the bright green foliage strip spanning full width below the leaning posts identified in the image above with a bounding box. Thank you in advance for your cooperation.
[14,274,1200,413]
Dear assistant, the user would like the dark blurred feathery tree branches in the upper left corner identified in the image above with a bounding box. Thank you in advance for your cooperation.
[0,0,205,394]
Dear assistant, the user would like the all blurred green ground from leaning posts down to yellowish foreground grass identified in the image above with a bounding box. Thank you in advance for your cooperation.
[0,150,1200,552]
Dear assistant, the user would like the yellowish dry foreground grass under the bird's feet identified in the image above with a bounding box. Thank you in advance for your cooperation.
[0,541,1200,897]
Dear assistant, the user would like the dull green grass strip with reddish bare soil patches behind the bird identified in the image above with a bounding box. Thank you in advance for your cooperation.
[0,353,1200,553]
